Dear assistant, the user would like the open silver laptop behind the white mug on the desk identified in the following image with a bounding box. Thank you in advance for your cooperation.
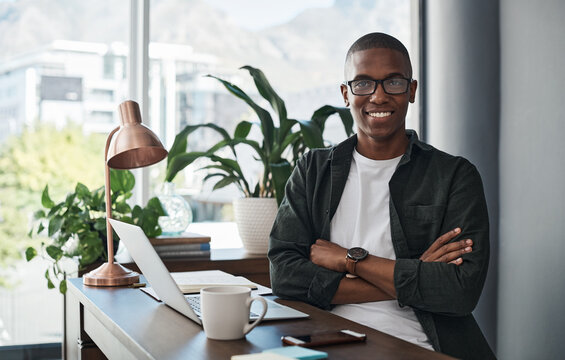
[109,219,309,325]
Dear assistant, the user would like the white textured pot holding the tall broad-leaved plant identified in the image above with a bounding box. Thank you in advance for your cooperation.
[233,198,278,254]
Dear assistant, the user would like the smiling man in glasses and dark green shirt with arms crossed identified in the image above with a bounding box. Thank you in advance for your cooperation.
[269,33,494,359]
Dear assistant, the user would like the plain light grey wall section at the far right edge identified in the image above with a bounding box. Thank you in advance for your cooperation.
[498,0,565,359]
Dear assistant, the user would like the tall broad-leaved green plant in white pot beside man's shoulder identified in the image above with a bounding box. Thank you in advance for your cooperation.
[166,66,353,253]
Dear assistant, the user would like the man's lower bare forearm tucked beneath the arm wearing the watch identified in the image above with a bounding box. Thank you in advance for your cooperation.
[332,277,394,305]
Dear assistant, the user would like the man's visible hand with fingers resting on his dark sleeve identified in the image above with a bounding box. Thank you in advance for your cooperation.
[420,228,473,265]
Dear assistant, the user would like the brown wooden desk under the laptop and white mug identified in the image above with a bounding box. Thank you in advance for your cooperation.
[64,278,450,360]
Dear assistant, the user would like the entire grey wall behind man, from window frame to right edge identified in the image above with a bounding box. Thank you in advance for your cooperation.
[425,0,565,360]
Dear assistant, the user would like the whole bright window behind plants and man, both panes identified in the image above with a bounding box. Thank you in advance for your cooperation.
[0,0,417,357]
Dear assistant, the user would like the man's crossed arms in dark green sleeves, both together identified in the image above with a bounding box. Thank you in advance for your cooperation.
[269,152,489,316]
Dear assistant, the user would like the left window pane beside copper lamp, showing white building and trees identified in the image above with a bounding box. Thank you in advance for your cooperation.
[0,0,129,352]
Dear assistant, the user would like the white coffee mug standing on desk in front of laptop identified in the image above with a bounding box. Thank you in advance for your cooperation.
[200,286,267,340]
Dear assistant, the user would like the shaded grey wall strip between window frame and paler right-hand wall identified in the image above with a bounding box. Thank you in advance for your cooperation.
[423,0,500,350]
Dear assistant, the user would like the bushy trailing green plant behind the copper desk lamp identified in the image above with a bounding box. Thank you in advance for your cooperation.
[26,169,165,294]
